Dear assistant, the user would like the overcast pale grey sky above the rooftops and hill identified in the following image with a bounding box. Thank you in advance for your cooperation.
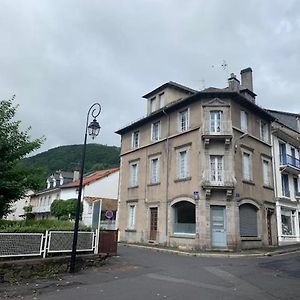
[0,0,300,151]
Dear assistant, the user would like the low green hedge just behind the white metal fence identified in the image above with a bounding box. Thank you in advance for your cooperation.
[0,220,91,233]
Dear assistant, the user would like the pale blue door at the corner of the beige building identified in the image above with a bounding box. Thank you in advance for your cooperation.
[210,206,227,247]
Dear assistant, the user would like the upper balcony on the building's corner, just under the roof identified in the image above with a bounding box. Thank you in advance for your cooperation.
[201,119,232,144]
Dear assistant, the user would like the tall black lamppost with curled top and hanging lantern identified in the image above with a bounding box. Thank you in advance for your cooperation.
[70,103,101,273]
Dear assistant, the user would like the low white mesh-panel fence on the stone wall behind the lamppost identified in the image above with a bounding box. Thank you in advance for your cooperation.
[0,230,99,258]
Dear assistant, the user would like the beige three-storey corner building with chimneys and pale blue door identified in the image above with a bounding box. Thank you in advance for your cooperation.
[116,68,277,250]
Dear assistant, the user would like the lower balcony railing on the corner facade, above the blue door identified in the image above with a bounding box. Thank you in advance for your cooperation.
[202,170,236,187]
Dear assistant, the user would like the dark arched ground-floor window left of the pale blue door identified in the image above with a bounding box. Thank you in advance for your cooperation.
[172,201,196,234]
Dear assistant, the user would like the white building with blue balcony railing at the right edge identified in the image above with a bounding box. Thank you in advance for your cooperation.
[269,110,300,245]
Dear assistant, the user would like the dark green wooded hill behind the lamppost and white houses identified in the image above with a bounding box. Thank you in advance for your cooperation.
[23,144,120,176]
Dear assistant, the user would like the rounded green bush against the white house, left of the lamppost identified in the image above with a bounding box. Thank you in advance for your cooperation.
[50,199,83,220]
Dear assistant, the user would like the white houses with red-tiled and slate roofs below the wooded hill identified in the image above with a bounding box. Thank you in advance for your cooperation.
[30,168,119,226]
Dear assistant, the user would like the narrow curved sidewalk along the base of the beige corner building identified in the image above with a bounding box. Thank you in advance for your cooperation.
[121,243,300,258]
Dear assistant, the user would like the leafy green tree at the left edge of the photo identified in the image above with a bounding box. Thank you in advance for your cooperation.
[0,96,44,219]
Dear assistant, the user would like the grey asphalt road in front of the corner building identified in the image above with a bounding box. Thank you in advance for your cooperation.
[3,245,300,300]
